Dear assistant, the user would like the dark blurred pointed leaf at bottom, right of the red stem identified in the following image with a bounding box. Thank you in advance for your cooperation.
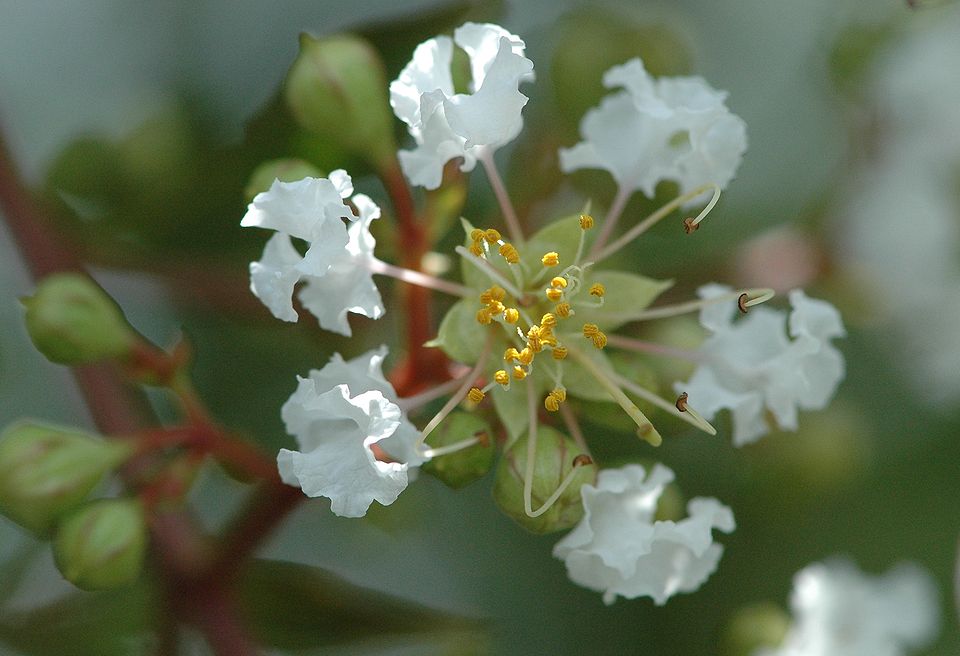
[241,560,480,650]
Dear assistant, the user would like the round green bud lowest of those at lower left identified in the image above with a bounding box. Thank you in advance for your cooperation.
[53,499,147,590]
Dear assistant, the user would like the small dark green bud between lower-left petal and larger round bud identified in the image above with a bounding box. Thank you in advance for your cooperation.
[421,412,496,490]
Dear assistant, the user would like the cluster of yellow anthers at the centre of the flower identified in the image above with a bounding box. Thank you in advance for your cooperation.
[468,214,607,412]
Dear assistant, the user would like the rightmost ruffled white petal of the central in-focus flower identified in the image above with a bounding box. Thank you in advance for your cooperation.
[675,285,845,446]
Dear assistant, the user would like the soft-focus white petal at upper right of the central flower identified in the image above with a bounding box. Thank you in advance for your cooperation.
[560,59,747,197]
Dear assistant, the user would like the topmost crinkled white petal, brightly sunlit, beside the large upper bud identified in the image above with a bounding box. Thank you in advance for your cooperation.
[390,23,533,189]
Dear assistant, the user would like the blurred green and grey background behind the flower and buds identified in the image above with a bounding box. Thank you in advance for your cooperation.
[0,0,960,656]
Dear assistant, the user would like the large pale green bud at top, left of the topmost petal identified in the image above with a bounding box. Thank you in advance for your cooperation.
[283,34,397,169]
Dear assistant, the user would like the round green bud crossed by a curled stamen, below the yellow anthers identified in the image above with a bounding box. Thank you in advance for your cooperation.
[493,426,597,533]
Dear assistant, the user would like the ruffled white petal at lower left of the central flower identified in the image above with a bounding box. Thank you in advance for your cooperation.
[277,347,423,517]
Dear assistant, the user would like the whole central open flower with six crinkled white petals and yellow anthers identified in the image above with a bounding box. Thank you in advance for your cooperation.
[242,23,843,604]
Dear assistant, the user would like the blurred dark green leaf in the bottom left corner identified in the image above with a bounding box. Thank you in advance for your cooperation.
[0,585,153,656]
